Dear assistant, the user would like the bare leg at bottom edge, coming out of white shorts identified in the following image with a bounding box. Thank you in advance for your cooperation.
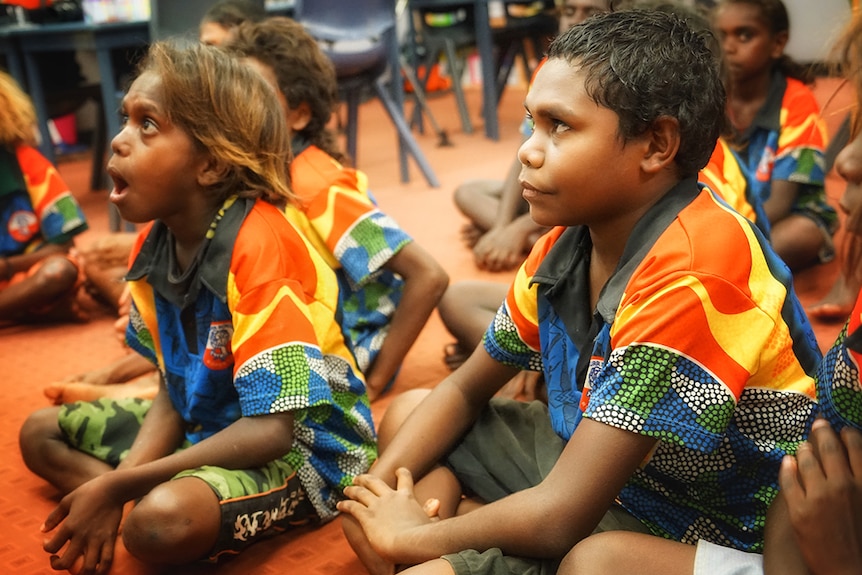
[557,531,696,575]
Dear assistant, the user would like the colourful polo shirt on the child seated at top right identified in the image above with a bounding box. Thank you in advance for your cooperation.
[731,72,838,233]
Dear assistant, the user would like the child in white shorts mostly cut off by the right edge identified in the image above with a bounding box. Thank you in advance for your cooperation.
[559,12,862,575]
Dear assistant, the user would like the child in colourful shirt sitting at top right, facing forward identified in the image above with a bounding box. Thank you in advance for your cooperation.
[714,0,837,271]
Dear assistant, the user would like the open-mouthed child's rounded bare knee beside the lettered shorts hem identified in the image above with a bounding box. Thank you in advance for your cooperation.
[123,477,221,565]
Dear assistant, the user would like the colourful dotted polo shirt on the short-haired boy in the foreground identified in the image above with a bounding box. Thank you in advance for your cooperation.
[485,179,820,550]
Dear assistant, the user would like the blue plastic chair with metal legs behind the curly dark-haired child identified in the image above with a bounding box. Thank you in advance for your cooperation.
[294,0,440,188]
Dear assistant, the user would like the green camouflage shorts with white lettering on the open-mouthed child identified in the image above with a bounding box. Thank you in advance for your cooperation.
[59,398,319,561]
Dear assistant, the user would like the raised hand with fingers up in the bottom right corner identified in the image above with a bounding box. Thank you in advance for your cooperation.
[779,419,862,575]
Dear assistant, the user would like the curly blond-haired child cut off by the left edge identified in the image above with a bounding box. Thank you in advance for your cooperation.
[0,71,88,322]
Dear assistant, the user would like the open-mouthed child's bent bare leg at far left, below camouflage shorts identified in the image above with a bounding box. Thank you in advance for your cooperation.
[18,407,111,495]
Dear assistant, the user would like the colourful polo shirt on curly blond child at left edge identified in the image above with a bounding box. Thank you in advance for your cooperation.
[0,145,87,256]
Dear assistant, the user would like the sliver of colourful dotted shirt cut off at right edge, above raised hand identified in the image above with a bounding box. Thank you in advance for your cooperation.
[817,297,862,431]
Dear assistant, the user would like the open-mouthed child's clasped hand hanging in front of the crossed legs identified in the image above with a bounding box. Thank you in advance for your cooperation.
[42,476,123,575]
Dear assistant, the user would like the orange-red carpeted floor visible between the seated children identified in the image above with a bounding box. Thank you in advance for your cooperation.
[0,80,849,575]
